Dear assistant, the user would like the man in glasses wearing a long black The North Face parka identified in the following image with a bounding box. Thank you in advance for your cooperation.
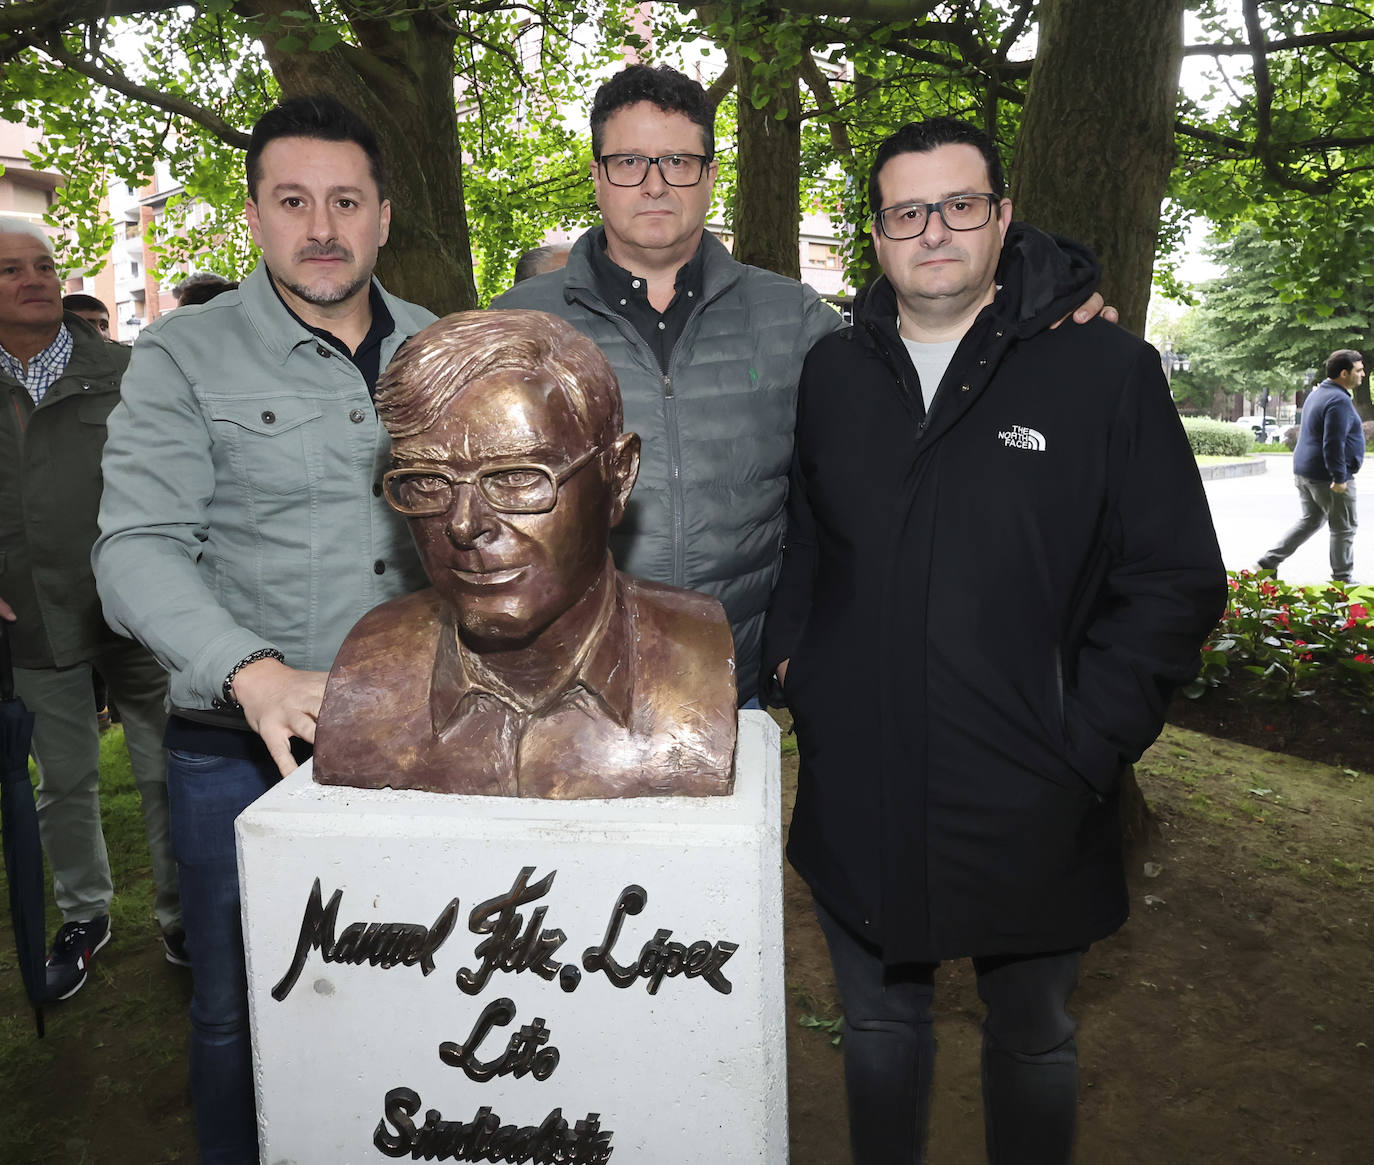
[763,118,1226,1165]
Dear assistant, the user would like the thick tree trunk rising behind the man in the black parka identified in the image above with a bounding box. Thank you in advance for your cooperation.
[1011,0,1184,335]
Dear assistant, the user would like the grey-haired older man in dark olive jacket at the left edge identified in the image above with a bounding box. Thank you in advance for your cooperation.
[0,218,187,999]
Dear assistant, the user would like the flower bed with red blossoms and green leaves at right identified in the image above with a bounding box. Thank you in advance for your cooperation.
[1183,570,1374,703]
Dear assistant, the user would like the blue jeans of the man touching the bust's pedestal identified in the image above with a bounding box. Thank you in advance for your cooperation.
[168,749,280,1165]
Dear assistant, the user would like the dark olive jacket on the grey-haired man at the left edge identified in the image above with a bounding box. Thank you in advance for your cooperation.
[0,312,129,668]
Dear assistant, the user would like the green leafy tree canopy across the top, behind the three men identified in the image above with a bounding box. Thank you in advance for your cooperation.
[8,0,1374,321]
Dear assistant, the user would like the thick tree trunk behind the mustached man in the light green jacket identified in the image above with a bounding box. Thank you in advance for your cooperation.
[264,11,478,315]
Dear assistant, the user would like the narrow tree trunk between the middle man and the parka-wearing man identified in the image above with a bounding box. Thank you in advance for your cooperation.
[734,46,801,279]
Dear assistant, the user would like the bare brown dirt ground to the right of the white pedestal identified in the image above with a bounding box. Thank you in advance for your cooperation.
[785,728,1374,1165]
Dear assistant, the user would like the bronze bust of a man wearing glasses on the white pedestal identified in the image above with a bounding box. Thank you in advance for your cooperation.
[315,312,735,798]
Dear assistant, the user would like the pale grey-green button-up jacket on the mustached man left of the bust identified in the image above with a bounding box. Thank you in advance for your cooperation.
[95,264,434,709]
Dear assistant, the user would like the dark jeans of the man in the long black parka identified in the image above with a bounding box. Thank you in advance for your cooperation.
[816,903,1083,1165]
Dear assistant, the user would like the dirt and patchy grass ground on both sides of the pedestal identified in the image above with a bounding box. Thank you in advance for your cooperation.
[0,728,1374,1165]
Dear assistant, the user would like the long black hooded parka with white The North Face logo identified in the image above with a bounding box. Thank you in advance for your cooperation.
[764,222,1226,963]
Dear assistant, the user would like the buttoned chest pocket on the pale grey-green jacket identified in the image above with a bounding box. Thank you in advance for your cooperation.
[210,400,324,495]
